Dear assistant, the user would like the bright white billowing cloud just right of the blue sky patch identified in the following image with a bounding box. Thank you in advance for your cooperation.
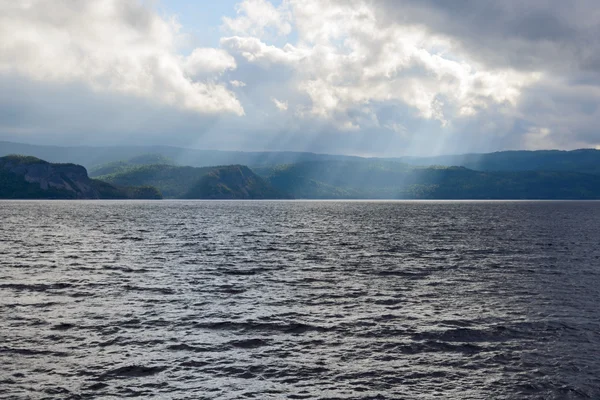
[221,0,541,129]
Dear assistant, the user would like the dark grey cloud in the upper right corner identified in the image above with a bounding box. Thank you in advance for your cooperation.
[374,0,600,73]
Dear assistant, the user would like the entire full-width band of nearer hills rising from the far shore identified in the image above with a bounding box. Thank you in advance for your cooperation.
[0,152,600,200]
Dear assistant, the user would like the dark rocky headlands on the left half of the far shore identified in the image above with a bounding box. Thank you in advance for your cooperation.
[0,155,288,199]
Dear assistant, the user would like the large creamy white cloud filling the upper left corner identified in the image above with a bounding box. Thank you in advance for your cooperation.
[0,0,244,115]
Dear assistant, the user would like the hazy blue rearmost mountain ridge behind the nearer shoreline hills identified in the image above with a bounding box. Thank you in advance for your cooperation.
[0,141,600,176]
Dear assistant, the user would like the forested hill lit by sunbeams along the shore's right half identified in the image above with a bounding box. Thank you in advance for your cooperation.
[256,161,600,199]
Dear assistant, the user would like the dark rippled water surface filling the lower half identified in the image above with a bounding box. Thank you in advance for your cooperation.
[0,201,600,399]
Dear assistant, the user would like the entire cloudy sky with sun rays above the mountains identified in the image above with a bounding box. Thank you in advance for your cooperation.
[0,0,600,156]
